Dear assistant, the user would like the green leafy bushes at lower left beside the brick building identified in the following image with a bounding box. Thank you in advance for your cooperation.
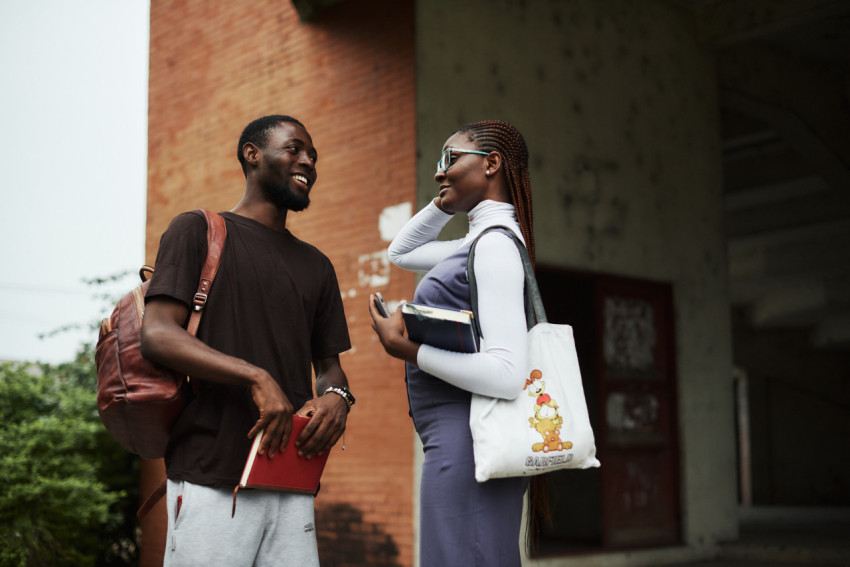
[0,345,138,567]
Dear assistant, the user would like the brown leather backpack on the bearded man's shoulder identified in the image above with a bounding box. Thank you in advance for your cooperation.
[95,210,227,459]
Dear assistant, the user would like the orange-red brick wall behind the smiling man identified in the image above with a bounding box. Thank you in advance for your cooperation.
[146,0,416,565]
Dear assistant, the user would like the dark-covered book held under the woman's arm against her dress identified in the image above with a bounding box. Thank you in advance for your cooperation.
[401,303,478,352]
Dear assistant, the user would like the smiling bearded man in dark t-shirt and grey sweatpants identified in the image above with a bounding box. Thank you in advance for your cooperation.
[142,115,354,567]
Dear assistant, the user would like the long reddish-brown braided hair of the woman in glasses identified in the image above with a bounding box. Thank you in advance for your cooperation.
[456,120,534,265]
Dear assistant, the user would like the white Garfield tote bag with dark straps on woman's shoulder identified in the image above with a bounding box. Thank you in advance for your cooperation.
[467,227,600,482]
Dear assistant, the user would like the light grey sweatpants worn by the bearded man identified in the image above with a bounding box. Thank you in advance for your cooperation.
[163,480,319,567]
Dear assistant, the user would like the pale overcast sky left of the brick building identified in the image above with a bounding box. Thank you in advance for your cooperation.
[0,0,150,363]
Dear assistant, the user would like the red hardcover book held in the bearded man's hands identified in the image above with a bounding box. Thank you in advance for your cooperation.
[233,415,330,513]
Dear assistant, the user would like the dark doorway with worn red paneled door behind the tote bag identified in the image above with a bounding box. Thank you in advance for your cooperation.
[537,267,681,555]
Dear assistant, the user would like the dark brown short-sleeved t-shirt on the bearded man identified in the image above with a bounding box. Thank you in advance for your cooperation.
[146,211,351,488]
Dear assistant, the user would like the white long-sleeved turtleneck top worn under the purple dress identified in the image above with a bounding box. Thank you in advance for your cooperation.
[388,200,526,399]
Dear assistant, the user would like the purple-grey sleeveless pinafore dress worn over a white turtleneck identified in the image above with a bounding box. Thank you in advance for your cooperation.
[406,241,528,567]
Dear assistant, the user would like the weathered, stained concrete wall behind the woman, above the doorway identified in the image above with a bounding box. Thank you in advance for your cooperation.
[416,0,737,565]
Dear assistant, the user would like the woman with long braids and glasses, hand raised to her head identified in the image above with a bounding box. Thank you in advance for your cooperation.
[369,121,534,567]
